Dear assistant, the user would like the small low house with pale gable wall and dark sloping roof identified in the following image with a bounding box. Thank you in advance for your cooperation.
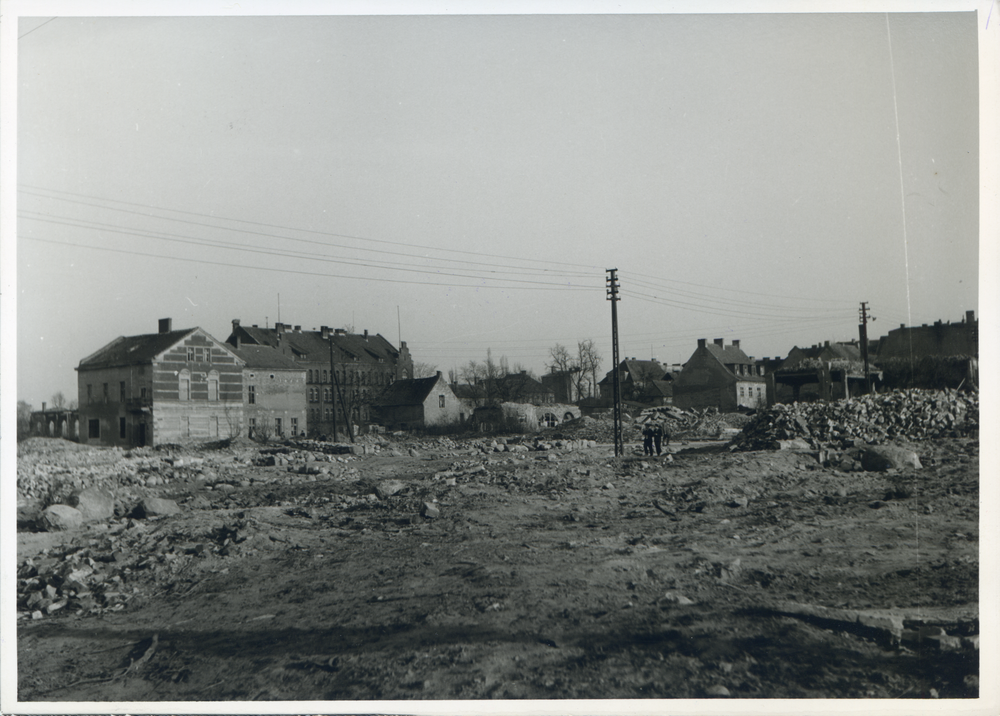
[373,371,467,430]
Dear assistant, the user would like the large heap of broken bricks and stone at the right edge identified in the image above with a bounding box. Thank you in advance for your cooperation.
[730,389,979,450]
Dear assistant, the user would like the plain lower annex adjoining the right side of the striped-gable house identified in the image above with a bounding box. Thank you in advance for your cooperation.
[232,345,309,438]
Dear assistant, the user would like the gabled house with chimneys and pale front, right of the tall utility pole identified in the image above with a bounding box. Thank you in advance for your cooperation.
[673,338,767,412]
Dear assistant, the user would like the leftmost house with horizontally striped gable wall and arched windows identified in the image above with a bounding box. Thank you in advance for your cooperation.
[76,318,243,447]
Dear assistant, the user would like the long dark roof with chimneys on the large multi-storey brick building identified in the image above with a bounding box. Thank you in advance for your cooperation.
[226,326,399,363]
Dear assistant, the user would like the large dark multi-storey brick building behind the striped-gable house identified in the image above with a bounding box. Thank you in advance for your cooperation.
[226,319,413,436]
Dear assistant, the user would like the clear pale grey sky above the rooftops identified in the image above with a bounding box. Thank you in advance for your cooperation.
[3,5,980,408]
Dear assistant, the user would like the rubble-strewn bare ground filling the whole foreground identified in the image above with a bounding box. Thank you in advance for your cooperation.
[17,391,979,702]
